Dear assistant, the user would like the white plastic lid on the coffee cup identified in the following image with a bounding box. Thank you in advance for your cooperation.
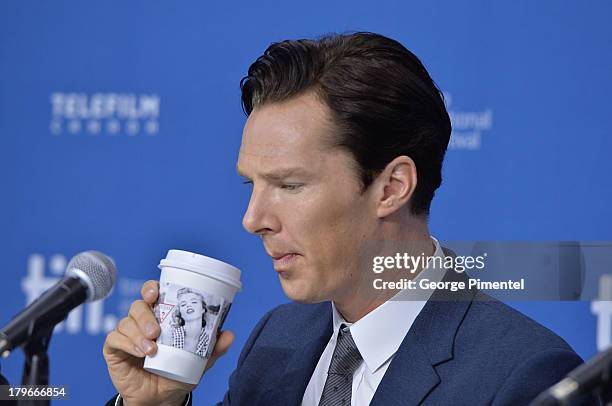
[158,250,242,291]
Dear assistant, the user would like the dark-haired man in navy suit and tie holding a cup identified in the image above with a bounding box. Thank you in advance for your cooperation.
[104,33,581,406]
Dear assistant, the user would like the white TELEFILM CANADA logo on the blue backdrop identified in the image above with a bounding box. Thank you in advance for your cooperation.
[49,92,160,136]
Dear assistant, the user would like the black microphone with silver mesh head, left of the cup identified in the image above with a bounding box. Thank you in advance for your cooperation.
[0,251,117,357]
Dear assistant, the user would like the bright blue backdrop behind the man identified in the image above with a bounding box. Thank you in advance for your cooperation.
[0,0,612,405]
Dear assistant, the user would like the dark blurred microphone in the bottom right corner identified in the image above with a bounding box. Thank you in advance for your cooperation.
[531,348,612,406]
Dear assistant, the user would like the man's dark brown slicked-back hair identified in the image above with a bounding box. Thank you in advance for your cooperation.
[240,32,451,216]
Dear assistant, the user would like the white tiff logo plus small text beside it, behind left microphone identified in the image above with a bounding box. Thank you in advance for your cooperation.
[21,254,144,335]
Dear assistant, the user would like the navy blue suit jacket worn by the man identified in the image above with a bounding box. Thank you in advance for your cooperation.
[109,272,582,406]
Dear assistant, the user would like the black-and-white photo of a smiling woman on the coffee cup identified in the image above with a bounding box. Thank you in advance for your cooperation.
[155,283,226,358]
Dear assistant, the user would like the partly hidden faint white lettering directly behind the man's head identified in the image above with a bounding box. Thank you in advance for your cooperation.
[442,92,493,151]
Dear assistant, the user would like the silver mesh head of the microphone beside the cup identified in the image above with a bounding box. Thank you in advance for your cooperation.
[66,251,117,302]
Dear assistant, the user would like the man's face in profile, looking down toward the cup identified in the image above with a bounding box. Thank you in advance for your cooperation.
[238,93,376,302]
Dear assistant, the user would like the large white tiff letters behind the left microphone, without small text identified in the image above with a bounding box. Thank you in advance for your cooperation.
[21,254,117,334]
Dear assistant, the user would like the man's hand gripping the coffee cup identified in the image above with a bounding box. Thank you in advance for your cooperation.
[103,281,234,406]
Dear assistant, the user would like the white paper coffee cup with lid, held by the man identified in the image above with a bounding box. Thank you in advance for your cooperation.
[144,250,242,384]
